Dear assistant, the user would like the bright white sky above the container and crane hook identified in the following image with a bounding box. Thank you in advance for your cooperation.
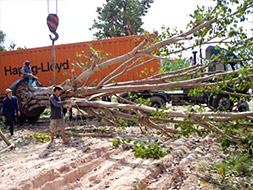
[0,0,252,48]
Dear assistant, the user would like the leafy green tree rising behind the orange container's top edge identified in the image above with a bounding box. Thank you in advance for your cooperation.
[90,0,154,39]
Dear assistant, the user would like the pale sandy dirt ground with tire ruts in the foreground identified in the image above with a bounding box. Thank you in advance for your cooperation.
[0,104,252,190]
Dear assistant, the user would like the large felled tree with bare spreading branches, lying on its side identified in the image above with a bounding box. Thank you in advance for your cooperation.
[14,0,253,151]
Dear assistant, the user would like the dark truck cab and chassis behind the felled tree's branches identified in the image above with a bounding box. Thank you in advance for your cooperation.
[121,46,247,111]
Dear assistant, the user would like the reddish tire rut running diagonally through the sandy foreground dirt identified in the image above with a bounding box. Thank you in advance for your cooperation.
[19,146,120,190]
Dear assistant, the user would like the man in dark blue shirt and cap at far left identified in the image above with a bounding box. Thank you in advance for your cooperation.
[1,88,20,136]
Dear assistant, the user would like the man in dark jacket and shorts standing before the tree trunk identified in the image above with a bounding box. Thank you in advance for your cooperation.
[48,86,70,147]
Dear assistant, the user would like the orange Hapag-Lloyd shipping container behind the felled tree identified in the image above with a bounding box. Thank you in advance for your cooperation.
[0,35,160,97]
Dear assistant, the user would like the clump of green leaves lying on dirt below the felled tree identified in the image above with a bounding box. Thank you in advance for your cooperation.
[112,138,172,159]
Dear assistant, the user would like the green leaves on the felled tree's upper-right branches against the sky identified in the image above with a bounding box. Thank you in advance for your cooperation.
[157,0,253,63]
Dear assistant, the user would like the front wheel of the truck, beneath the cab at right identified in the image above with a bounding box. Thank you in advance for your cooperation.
[212,94,233,111]
